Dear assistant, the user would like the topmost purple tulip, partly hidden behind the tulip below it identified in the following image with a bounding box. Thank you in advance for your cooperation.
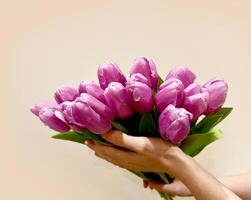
[130,57,159,89]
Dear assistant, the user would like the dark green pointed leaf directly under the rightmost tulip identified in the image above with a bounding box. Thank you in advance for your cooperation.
[190,108,233,134]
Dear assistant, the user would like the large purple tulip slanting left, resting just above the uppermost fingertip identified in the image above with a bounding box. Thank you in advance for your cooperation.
[72,93,113,134]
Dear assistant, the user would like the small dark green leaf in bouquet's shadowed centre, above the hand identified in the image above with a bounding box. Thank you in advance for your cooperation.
[138,113,155,136]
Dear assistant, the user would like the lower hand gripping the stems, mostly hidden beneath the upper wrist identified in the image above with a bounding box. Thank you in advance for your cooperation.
[143,179,192,197]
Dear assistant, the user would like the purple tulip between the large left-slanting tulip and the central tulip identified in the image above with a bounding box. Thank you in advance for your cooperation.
[104,82,133,119]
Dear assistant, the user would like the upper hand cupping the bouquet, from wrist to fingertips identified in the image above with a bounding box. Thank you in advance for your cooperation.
[86,130,186,176]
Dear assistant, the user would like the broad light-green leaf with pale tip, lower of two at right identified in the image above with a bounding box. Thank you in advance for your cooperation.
[180,129,223,156]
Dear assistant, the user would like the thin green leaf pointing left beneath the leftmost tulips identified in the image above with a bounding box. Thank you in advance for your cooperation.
[52,130,111,146]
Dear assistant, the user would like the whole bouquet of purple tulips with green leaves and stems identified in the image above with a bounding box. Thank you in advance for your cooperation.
[31,57,232,200]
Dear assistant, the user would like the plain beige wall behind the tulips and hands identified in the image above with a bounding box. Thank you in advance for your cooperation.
[0,0,251,200]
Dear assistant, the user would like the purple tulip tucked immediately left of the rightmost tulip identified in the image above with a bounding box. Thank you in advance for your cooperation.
[183,83,208,122]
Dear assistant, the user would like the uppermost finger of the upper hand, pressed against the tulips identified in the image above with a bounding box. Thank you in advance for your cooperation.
[101,130,152,153]
